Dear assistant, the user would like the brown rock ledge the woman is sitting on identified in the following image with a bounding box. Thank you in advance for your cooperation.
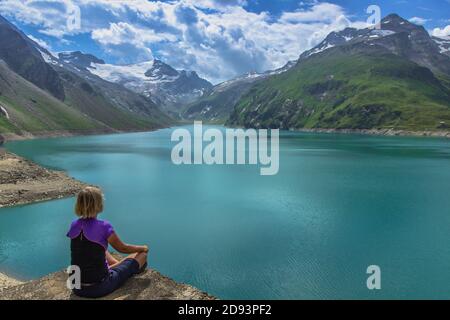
[0,269,215,300]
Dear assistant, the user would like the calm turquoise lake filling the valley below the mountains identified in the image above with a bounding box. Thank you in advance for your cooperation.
[0,125,450,299]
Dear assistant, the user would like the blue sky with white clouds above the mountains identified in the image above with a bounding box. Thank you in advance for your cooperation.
[0,0,450,82]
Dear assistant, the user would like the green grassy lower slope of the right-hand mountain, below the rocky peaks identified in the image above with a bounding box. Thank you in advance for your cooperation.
[227,49,450,130]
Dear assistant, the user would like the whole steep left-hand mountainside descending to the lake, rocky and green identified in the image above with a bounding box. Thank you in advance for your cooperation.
[0,17,172,135]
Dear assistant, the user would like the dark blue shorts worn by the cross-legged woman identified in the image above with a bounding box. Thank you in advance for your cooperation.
[73,258,139,298]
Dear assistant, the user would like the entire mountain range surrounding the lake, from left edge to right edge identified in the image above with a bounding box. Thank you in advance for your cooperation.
[0,14,450,136]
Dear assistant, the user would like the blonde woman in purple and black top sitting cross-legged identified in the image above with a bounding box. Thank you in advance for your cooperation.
[67,187,148,298]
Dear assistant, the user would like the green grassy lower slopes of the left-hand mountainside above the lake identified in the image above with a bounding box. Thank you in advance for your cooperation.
[0,60,172,135]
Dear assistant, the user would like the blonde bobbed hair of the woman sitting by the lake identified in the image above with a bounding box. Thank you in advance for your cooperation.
[75,187,103,219]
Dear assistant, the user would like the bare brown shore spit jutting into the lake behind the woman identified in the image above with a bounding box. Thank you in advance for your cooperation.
[0,150,86,208]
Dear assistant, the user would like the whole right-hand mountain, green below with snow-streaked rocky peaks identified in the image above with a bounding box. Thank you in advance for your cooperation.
[227,14,450,131]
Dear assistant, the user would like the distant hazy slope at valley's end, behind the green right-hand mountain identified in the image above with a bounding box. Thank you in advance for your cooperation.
[183,61,296,124]
